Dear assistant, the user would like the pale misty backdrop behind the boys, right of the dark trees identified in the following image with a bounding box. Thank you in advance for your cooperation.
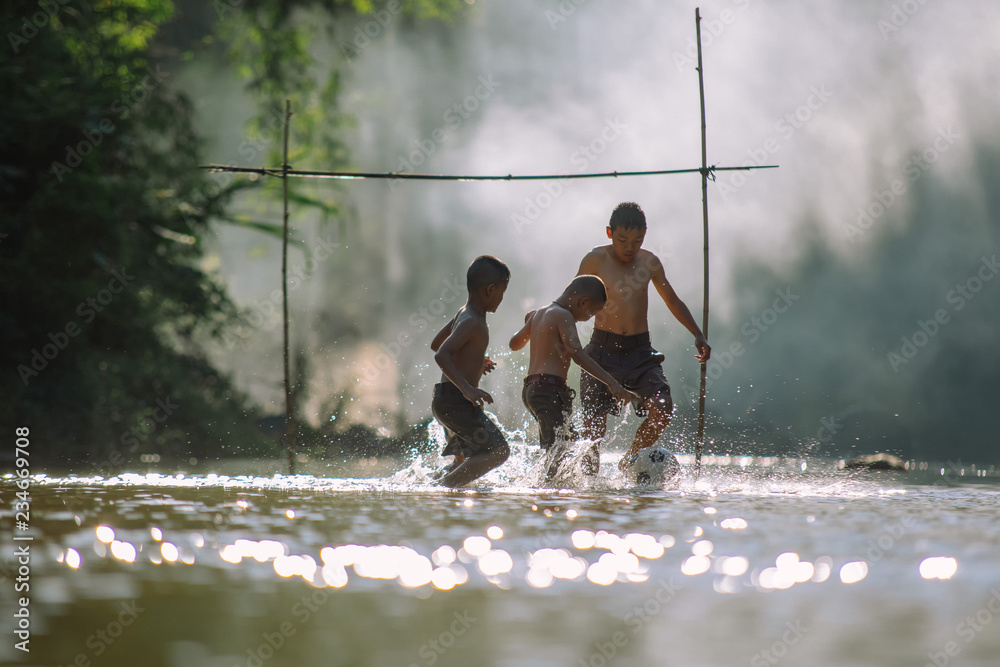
[174,0,1000,463]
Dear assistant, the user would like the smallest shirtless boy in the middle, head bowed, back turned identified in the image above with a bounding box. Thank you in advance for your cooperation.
[510,276,633,480]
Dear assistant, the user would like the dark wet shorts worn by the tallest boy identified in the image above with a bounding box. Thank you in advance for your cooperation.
[580,329,674,417]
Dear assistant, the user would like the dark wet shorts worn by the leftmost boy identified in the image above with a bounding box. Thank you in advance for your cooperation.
[431,382,507,457]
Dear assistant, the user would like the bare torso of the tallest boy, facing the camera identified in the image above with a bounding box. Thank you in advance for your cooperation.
[580,246,663,336]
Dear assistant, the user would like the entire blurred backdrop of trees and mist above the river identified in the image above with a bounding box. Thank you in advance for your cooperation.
[0,0,1000,468]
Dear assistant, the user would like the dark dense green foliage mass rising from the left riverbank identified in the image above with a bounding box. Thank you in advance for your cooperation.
[0,0,267,466]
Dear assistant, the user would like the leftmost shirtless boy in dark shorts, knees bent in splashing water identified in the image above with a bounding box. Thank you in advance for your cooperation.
[431,255,510,487]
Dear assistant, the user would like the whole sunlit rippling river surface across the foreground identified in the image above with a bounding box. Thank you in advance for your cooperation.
[0,446,1000,667]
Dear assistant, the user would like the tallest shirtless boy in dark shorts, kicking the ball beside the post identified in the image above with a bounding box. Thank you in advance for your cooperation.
[578,202,712,472]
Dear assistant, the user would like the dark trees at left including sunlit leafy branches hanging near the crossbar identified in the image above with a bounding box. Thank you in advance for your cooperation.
[0,0,460,469]
